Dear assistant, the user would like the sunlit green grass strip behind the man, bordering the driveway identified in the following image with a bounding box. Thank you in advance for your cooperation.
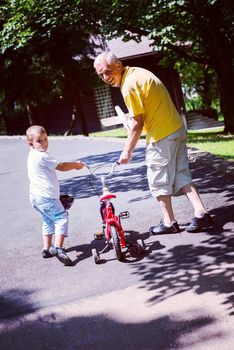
[90,128,234,160]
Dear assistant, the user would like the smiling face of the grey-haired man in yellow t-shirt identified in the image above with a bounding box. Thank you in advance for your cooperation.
[95,60,123,87]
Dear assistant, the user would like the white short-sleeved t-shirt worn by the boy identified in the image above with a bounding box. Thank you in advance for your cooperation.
[28,148,60,199]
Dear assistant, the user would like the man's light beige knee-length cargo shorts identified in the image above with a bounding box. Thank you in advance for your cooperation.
[146,127,192,197]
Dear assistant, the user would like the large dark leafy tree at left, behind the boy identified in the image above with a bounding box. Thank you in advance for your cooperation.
[0,0,103,135]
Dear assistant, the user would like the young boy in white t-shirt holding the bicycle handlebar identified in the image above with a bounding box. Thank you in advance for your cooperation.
[26,125,84,265]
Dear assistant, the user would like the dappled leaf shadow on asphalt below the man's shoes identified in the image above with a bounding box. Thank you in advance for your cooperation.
[132,234,234,315]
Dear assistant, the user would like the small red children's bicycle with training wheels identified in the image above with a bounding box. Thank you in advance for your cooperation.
[85,162,145,264]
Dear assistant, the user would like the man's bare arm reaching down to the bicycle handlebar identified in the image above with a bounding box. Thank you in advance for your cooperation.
[118,114,144,163]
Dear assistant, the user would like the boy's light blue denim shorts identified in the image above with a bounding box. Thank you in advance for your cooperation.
[30,194,68,236]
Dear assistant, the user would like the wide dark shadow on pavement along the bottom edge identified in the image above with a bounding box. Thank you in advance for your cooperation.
[0,292,221,350]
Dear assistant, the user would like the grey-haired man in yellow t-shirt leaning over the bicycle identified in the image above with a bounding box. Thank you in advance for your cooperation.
[94,52,213,234]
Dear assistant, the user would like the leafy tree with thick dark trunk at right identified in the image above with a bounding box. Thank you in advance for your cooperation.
[98,0,234,133]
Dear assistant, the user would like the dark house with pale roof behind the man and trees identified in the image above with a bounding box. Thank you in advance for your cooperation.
[6,37,184,135]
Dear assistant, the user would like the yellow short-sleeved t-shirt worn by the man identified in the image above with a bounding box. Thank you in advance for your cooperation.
[120,67,183,142]
